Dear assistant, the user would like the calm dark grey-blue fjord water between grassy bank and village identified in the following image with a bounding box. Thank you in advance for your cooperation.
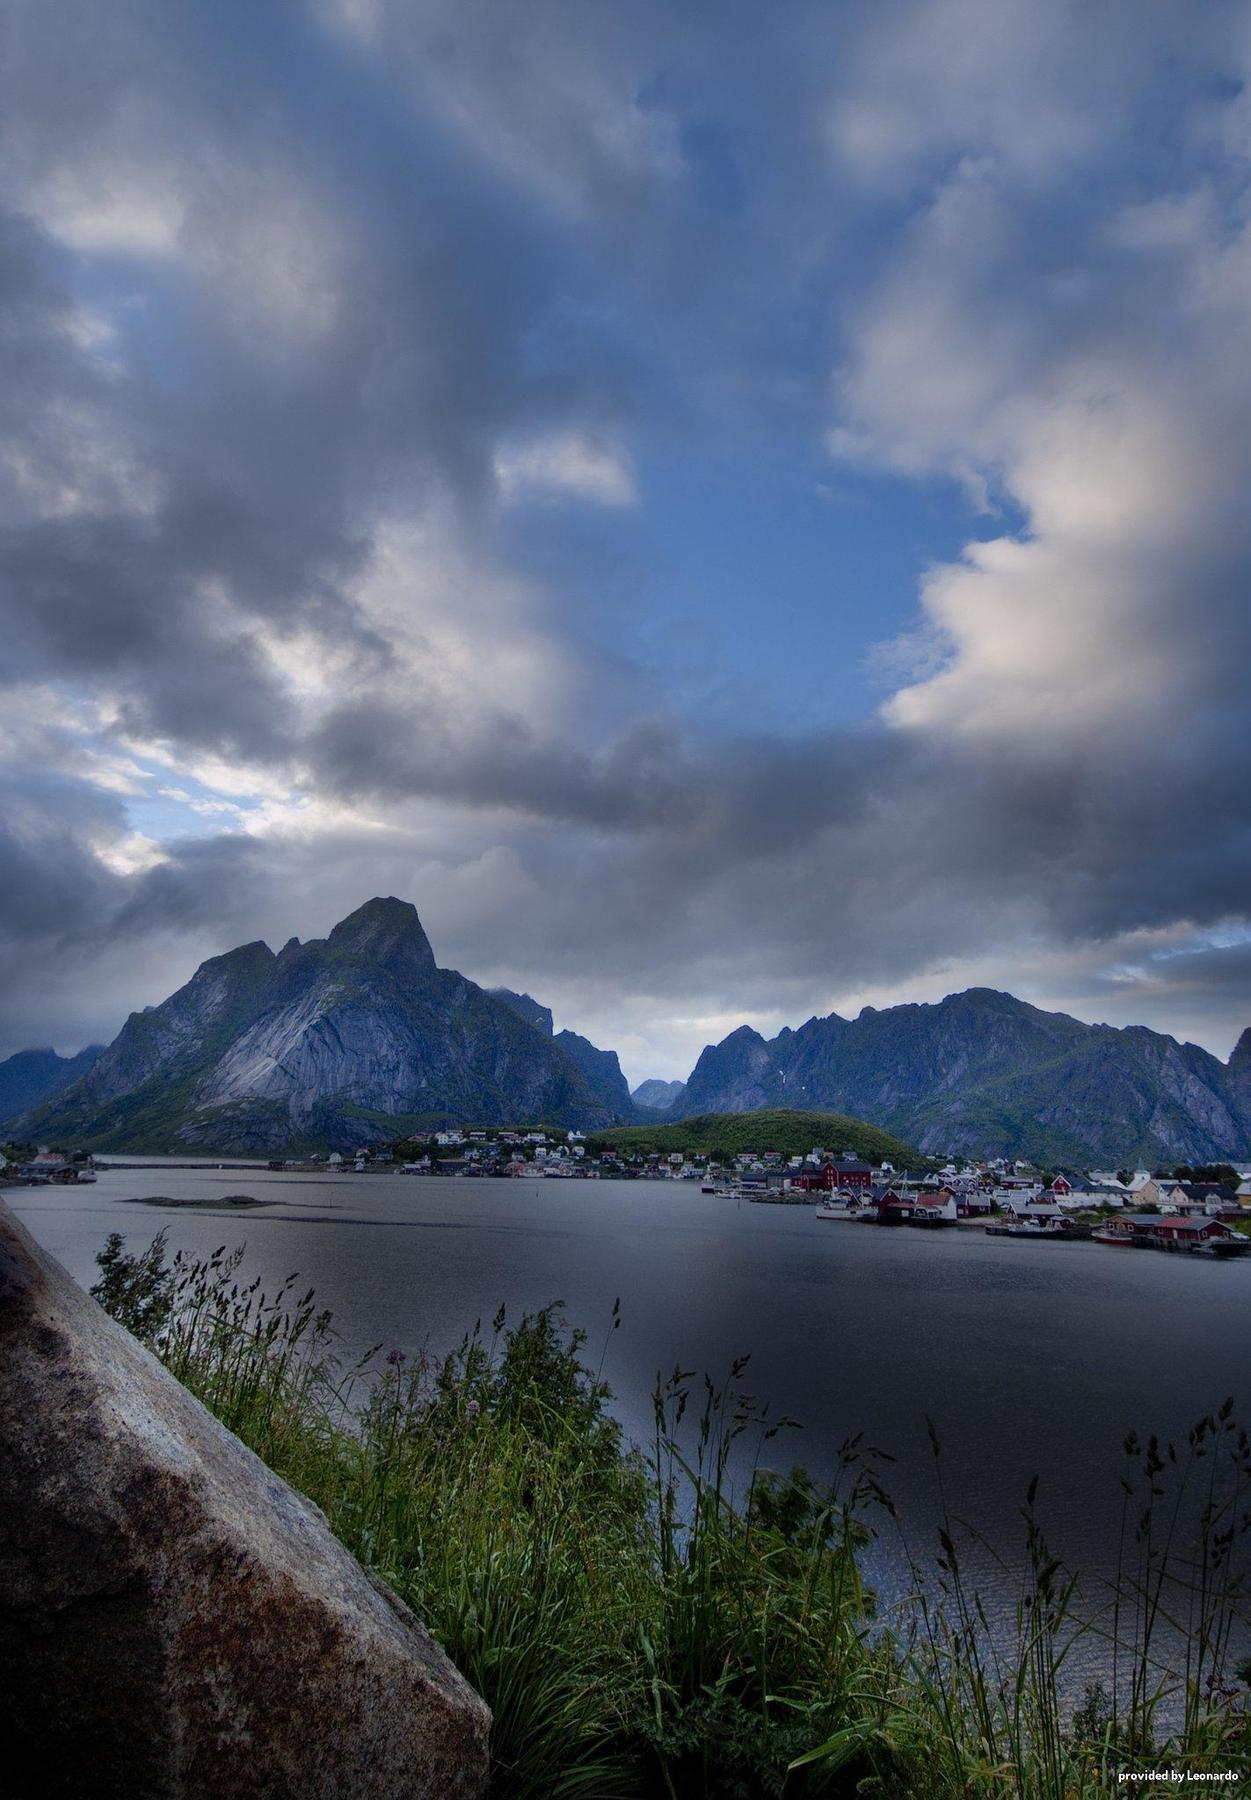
[5,1161,1251,1600]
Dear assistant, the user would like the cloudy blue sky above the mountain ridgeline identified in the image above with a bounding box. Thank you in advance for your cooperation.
[0,0,1251,1082]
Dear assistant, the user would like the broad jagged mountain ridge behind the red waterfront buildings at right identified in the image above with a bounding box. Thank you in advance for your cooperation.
[668,988,1251,1166]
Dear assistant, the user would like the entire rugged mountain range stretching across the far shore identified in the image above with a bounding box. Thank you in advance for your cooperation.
[9,898,1251,1166]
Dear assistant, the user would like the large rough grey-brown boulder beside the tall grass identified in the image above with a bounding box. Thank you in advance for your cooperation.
[0,1204,490,1800]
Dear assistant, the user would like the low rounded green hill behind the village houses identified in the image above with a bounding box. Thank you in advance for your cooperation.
[587,1107,923,1168]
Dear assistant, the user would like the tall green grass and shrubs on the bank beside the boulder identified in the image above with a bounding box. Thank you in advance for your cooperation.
[94,1235,1251,1800]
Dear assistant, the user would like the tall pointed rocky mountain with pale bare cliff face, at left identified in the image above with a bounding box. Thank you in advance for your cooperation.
[20,898,634,1154]
